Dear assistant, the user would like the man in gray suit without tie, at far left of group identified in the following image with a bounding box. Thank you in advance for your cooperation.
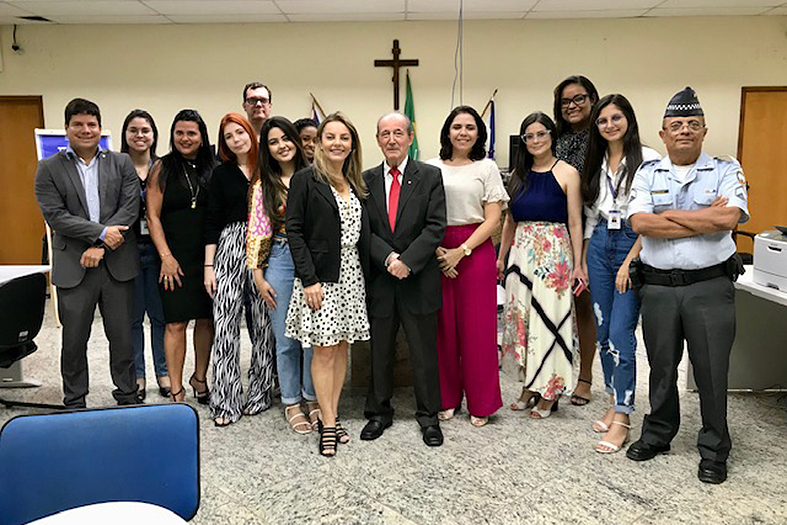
[35,98,139,408]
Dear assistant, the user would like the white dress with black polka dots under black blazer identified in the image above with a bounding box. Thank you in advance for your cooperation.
[286,187,369,346]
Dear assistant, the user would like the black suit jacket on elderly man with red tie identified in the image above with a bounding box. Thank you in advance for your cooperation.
[364,159,446,317]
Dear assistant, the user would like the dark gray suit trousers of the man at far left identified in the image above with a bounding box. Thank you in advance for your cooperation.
[57,262,137,408]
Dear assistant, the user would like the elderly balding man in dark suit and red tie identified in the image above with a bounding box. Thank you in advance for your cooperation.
[361,113,446,447]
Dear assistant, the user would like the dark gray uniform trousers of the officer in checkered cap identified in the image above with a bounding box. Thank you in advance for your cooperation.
[640,277,735,461]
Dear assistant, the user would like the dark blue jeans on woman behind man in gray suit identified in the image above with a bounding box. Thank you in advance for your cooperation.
[131,241,167,378]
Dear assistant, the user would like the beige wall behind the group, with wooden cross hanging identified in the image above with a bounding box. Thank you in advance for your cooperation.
[0,16,787,166]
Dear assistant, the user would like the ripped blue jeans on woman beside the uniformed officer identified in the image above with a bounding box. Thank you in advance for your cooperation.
[588,219,639,414]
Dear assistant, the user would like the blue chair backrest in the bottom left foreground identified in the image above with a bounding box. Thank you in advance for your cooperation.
[0,403,200,525]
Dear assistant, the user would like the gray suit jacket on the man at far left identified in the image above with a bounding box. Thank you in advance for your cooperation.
[35,151,139,288]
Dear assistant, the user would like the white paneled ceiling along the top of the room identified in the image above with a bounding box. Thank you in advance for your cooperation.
[0,0,787,25]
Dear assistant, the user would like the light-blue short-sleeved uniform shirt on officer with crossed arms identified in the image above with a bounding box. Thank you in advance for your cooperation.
[626,152,749,270]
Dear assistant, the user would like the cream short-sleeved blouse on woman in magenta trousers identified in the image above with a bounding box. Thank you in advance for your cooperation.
[427,158,508,226]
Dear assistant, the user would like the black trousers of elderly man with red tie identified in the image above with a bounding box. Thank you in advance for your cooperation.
[364,301,441,427]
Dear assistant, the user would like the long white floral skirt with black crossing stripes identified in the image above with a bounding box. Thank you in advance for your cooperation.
[502,222,579,400]
